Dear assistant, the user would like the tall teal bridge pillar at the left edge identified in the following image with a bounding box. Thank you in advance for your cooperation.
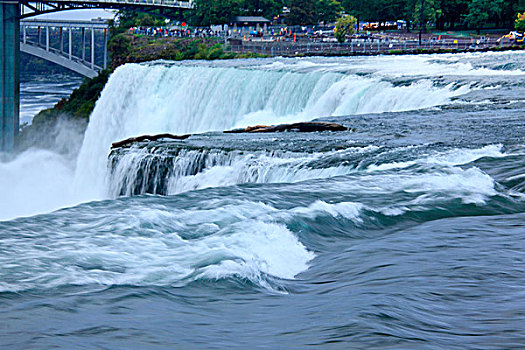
[0,1,20,152]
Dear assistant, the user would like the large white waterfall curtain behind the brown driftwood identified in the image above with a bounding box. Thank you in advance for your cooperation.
[76,58,478,197]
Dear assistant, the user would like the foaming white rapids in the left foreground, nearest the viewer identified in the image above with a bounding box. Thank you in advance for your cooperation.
[0,201,315,292]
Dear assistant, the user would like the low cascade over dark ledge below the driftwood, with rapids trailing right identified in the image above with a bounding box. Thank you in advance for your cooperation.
[108,145,506,203]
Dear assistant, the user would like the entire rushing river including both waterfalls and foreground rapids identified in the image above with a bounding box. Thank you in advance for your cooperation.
[0,53,525,349]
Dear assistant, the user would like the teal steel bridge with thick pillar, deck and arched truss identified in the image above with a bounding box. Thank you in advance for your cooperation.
[0,0,193,152]
